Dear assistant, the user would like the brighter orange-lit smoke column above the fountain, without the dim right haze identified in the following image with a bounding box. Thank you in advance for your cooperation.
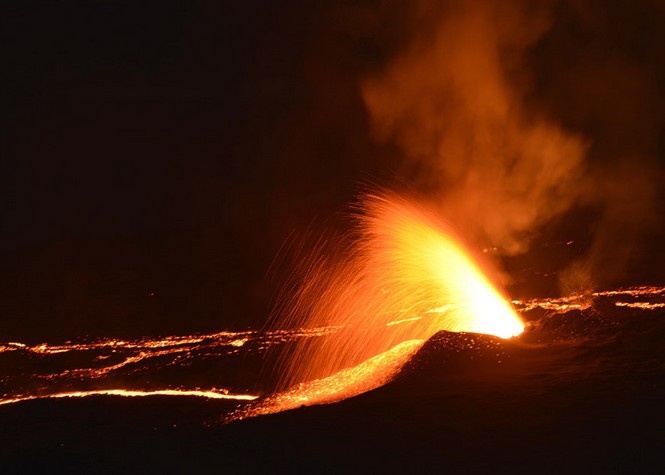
[363,1,585,253]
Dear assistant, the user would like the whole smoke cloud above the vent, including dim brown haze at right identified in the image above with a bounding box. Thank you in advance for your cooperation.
[362,0,664,290]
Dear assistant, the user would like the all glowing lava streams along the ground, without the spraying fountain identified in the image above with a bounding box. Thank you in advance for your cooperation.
[0,286,665,420]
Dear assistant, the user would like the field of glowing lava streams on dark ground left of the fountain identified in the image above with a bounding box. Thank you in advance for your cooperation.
[0,328,337,405]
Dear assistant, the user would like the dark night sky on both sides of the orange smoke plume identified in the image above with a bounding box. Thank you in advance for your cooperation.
[0,0,665,341]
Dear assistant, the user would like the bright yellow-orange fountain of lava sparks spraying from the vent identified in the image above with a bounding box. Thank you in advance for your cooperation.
[279,194,524,388]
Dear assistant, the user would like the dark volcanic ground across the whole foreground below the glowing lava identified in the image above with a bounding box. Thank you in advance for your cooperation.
[0,297,665,473]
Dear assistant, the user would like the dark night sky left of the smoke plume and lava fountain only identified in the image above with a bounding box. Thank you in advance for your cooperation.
[0,1,390,340]
